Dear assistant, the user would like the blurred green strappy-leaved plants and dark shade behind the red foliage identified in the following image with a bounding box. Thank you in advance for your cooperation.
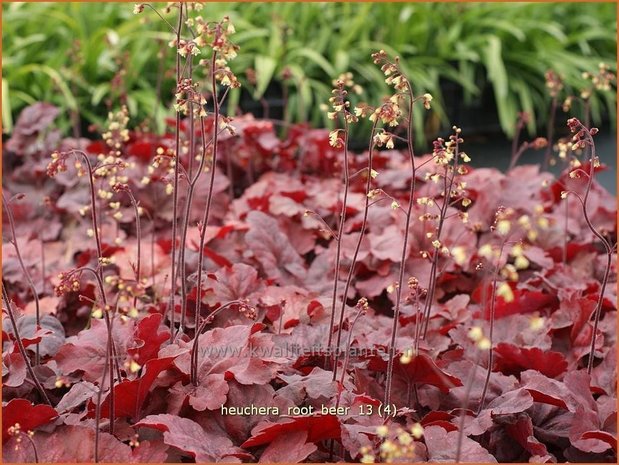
[2,3,617,185]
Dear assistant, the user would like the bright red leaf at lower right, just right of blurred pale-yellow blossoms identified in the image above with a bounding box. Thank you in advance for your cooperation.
[494,342,567,378]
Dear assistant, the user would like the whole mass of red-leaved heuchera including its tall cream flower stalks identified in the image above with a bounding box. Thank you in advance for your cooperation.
[2,3,617,463]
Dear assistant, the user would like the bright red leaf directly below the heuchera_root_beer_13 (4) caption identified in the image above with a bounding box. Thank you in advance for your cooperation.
[241,415,342,448]
